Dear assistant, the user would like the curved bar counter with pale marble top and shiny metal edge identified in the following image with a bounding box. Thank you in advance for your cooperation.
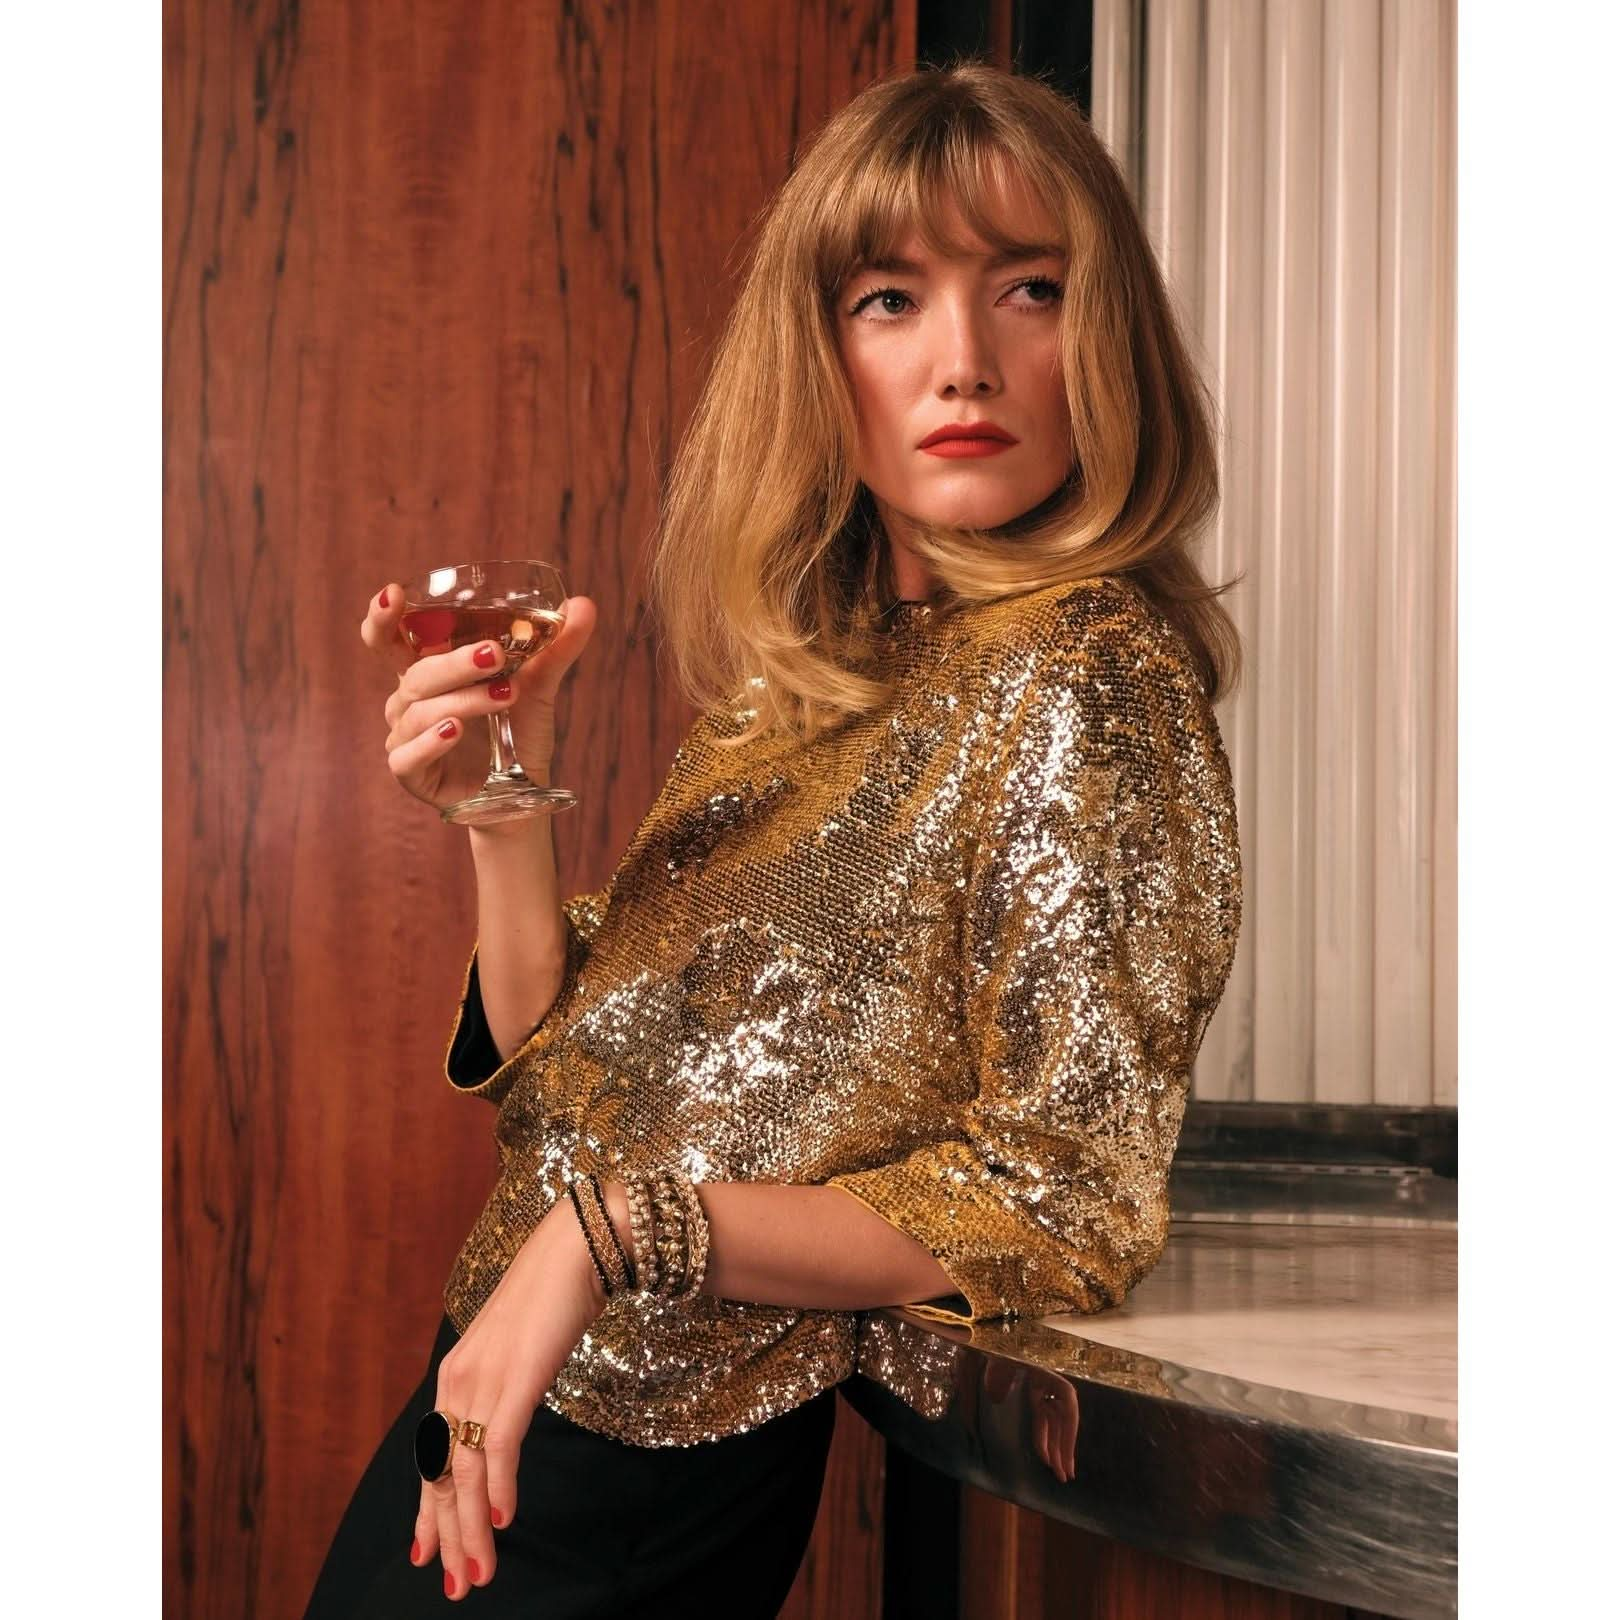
[844,1213,1456,1620]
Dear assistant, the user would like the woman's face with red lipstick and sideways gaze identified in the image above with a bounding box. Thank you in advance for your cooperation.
[838,172,1074,561]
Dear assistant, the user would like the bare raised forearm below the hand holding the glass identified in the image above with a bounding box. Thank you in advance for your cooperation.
[467,787,567,1061]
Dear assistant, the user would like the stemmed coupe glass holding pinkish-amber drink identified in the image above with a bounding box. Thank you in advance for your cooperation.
[400,557,577,826]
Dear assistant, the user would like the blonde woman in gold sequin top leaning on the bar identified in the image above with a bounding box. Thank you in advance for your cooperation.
[308,63,1241,1620]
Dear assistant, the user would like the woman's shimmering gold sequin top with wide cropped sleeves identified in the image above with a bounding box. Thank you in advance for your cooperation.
[444,577,1241,1445]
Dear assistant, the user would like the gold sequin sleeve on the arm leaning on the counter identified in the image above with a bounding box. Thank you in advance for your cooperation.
[829,619,1241,1324]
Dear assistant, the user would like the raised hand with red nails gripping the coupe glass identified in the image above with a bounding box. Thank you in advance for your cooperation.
[360,582,596,810]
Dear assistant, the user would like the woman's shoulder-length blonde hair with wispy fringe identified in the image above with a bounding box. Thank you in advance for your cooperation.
[651,60,1241,745]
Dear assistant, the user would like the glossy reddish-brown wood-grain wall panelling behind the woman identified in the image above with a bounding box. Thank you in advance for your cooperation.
[162,0,915,1620]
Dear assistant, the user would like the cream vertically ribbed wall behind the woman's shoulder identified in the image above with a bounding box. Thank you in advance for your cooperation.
[1092,0,1456,1105]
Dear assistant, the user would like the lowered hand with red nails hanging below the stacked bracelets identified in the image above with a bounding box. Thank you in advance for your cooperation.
[411,1197,606,1597]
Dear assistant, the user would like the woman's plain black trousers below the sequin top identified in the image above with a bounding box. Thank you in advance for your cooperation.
[305,1317,836,1620]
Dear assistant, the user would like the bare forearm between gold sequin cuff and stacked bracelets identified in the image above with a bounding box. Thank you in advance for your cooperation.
[589,1181,956,1311]
